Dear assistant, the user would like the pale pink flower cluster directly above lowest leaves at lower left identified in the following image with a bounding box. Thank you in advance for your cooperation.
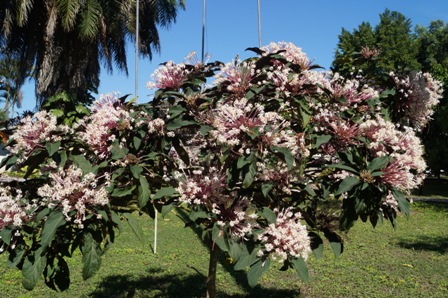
[37,166,109,228]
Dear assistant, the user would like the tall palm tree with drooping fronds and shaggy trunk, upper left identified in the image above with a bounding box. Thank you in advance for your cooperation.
[0,0,185,104]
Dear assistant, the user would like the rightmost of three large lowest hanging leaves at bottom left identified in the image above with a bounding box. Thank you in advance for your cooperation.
[81,232,102,280]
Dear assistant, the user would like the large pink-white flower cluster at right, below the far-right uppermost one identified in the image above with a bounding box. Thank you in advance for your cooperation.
[359,116,426,192]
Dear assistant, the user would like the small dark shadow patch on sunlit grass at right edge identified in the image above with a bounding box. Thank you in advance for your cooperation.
[397,235,448,254]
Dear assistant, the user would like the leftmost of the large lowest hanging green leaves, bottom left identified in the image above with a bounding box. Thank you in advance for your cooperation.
[22,247,47,290]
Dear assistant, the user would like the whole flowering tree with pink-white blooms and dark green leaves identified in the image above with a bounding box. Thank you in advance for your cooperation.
[0,43,441,297]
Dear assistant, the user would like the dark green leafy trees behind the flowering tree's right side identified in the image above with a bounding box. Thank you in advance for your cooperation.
[332,10,448,174]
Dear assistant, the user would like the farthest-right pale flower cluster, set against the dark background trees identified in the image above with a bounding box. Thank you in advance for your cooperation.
[390,72,443,129]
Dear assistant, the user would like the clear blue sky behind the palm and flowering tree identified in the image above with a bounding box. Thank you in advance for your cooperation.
[19,0,448,112]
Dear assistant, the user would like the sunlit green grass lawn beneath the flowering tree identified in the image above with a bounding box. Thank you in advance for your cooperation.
[0,180,448,298]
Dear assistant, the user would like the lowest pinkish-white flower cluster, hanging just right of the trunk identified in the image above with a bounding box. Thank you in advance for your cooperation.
[258,208,311,263]
